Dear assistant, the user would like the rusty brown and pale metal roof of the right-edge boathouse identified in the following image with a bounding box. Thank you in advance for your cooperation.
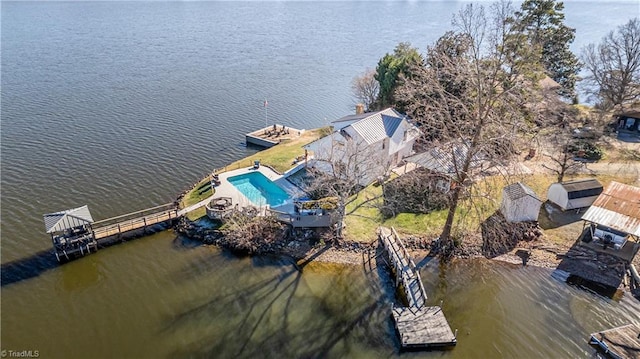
[582,181,640,237]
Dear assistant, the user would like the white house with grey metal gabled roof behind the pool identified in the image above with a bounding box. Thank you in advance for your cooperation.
[305,108,420,185]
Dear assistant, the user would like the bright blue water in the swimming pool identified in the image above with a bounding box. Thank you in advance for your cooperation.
[229,172,289,207]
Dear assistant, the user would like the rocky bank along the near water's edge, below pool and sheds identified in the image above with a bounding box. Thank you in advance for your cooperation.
[174,220,640,297]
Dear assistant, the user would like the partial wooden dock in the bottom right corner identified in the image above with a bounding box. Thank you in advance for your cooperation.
[589,324,640,359]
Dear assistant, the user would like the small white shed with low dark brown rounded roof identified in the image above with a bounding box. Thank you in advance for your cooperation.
[547,178,602,211]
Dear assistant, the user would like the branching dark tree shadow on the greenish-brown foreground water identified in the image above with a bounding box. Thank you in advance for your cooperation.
[163,248,393,358]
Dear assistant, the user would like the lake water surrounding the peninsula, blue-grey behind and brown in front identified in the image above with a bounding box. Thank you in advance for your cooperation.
[0,1,640,358]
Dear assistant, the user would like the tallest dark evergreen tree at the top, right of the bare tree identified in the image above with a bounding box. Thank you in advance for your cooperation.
[515,0,580,98]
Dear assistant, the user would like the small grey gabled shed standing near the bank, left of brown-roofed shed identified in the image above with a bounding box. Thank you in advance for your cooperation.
[500,182,542,223]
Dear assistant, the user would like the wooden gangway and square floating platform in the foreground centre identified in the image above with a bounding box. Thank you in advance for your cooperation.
[378,227,457,349]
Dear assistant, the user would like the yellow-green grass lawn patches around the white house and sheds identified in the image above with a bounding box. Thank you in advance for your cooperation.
[181,124,635,243]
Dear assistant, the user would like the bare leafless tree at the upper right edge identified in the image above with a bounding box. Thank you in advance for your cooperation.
[581,18,640,109]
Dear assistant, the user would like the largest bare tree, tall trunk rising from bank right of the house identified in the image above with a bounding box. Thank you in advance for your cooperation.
[397,2,536,248]
